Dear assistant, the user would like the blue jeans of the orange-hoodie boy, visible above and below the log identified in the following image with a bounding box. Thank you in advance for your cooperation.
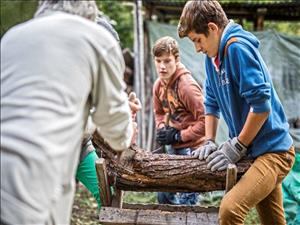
[157,145,199,205]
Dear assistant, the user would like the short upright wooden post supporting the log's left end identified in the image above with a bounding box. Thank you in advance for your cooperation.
[96,158,111,206]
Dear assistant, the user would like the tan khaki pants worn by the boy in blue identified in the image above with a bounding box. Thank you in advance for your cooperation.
[219,147,295,225]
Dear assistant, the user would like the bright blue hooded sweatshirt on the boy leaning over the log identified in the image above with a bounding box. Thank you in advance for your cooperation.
[205,22,292,158]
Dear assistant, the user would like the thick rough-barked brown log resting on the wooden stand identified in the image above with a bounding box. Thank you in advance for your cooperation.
[93,132,251,192]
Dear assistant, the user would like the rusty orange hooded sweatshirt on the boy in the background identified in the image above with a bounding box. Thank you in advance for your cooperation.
[153,63,205,149]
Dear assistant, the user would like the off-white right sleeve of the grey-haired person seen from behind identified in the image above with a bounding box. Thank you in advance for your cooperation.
[92,43,133,151]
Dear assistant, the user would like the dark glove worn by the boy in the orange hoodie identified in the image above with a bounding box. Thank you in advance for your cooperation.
[156,127,181,145]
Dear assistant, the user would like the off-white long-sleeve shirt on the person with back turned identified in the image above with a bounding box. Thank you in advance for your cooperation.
[1,12,132,224]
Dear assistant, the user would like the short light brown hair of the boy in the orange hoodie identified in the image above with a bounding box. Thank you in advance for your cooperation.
[152,36,179,59]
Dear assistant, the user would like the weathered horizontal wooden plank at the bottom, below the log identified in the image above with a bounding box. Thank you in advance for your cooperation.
[99,207,218,225]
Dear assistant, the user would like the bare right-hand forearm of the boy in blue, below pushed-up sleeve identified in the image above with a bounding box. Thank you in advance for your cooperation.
[238,112,269,146]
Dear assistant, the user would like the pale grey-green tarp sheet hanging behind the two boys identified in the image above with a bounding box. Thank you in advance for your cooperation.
[147,21,300,142]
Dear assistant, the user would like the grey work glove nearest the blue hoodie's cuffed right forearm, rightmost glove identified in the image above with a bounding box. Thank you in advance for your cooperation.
[206,137,247,171]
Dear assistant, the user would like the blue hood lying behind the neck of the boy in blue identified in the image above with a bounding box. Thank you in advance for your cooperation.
[218,21,260,63]
